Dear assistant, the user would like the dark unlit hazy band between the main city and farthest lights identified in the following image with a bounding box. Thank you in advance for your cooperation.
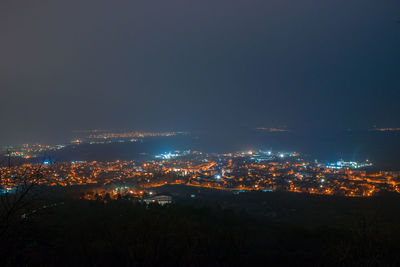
[41,131,400,170]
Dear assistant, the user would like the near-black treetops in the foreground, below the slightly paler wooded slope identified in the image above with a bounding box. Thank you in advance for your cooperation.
[0,196,400,266]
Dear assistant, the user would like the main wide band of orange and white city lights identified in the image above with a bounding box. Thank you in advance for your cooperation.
[0,151,400,200]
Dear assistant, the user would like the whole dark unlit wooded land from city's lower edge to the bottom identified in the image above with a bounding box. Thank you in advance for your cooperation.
[0,186,400,266]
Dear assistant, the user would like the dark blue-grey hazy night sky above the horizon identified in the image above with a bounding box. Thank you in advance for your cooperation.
[0,0,400,144]
